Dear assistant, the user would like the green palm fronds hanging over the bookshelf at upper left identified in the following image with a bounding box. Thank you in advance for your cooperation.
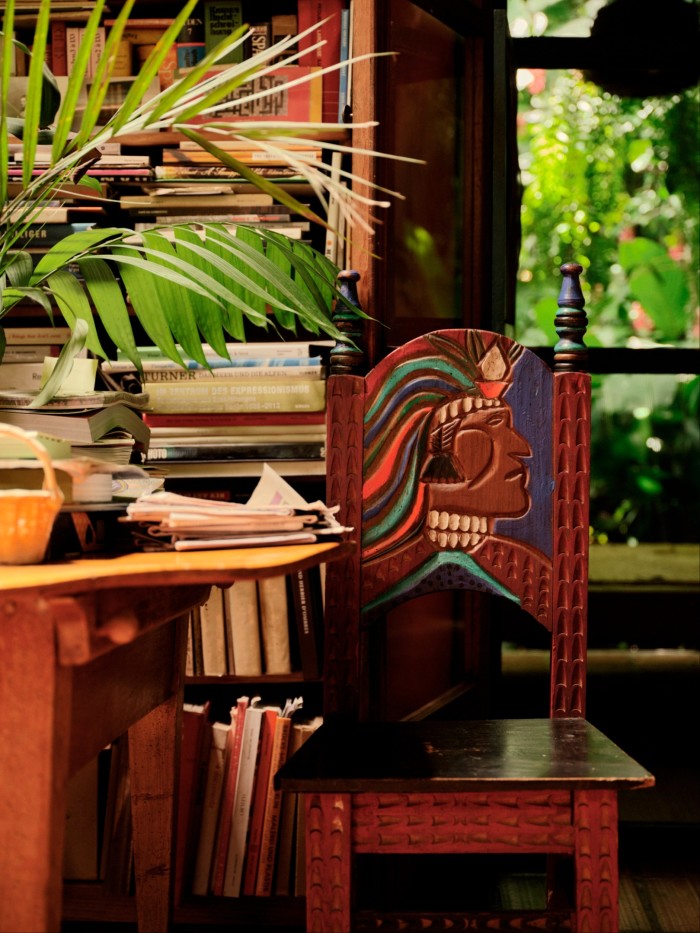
[0,0,410,405]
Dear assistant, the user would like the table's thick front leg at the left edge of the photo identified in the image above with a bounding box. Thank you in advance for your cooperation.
[0,595,72,933]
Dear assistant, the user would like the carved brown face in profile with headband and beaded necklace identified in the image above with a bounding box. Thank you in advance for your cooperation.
[424,397,532,549]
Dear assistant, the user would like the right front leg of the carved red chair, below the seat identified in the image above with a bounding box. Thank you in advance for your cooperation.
[574,790,619,933]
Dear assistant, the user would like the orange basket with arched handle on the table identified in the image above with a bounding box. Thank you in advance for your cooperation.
[0,424,63,564]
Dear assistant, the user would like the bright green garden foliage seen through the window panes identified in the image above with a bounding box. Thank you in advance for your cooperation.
[509,0,700,543]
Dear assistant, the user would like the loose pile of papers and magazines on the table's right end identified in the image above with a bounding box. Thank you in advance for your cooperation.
[122,464,351,551]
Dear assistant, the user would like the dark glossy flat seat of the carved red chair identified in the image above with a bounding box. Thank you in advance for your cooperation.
[276,718,654,793]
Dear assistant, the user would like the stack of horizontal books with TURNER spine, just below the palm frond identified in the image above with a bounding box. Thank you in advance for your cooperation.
[101,341,334,475]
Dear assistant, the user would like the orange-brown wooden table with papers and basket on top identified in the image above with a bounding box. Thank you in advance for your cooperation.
[0,544,344,933]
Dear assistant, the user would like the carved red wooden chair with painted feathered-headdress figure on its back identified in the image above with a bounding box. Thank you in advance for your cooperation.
[278,264,654,933]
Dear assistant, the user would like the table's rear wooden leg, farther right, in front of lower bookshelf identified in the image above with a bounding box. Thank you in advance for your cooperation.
[129,617,187,933]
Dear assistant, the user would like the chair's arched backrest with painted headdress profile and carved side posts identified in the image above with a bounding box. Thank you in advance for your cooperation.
[327,329,590,716]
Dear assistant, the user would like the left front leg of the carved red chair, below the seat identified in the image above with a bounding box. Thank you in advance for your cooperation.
[304,794,352,933]
